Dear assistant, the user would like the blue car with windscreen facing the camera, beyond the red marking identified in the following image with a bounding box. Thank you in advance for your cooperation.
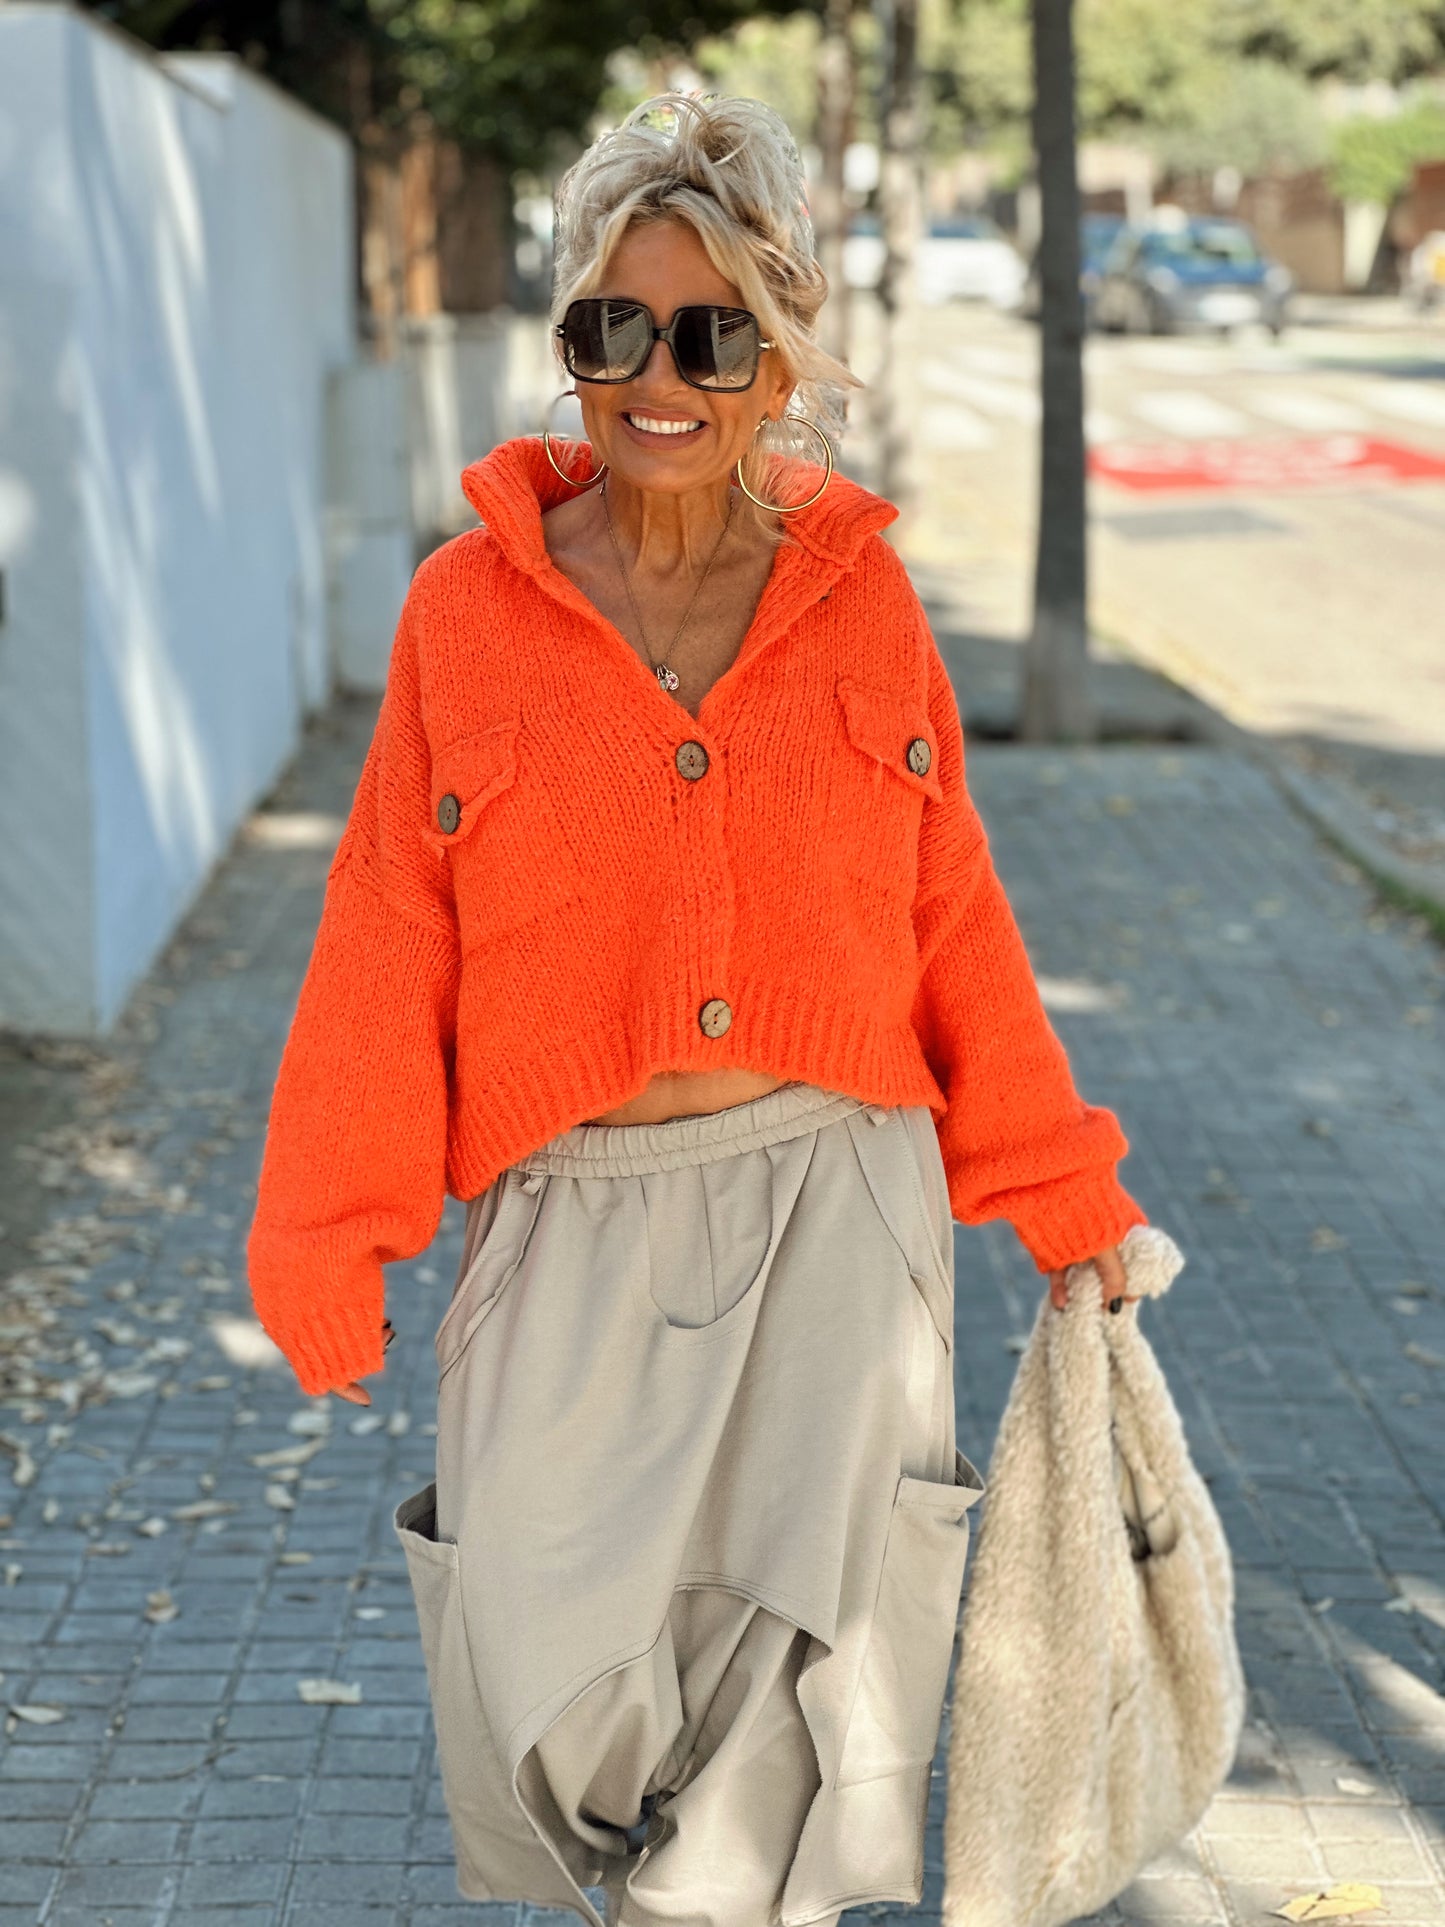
[1092,214,1295,335]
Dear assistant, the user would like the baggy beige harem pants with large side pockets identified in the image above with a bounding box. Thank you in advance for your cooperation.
[395,1083,985,1927]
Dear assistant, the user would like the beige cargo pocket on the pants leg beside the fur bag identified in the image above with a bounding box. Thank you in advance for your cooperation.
[838,1451,985,1786]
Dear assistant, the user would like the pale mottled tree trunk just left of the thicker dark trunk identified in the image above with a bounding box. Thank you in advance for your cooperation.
[875,0,919,526]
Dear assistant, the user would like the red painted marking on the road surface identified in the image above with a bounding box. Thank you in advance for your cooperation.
[1089,436,1445,493]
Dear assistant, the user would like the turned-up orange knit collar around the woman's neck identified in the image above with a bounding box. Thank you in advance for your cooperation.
[462,436,898,576]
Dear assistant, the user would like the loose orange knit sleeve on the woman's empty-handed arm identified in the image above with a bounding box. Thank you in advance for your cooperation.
[247,576,460,1393]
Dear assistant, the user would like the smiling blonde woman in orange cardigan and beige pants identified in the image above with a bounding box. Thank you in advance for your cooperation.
[249,96,1146,1927]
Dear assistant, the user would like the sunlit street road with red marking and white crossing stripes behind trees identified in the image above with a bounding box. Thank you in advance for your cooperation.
[846,304,1445,859]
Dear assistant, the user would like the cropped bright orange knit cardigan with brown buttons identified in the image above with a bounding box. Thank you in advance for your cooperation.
[247,437,1148,1393]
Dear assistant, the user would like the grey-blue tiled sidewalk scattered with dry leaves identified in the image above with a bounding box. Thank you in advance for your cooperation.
[0,686,1445,1927]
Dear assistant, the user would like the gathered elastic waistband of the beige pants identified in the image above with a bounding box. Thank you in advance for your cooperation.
[516,1083,877,1177]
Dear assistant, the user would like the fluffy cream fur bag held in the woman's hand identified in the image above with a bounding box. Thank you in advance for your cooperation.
[942,1226,1245,1927]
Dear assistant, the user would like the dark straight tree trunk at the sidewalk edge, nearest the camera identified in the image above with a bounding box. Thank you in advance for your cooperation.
[1019,0,1096,742]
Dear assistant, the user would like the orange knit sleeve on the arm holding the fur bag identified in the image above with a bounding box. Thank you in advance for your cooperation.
[913,620,1148,1272]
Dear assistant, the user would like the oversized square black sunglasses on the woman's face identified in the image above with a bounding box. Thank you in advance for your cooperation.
[553,295,773,393]
